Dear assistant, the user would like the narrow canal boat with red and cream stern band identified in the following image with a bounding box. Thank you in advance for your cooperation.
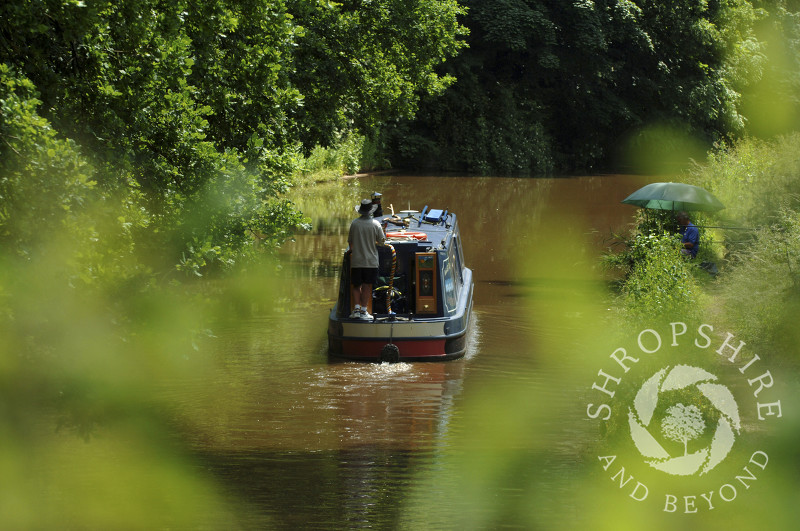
[328,206,473,362]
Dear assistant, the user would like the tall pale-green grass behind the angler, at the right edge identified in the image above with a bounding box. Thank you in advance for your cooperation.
[694,134,800,349]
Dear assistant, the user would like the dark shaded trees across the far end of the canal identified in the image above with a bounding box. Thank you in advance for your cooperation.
[389,0,797,173]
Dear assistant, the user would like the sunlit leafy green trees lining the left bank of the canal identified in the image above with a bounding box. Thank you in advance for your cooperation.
[0,0,463,274]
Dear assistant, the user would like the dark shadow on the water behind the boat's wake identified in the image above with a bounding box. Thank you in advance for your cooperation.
[201,446,424,529]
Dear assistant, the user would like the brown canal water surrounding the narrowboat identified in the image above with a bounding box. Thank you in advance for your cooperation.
[180,176,644,529]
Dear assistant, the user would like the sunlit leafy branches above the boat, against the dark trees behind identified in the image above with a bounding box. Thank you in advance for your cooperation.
[287,0,465,146]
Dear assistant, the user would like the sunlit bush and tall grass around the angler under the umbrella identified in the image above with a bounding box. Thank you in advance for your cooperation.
[604,134,800,352]
